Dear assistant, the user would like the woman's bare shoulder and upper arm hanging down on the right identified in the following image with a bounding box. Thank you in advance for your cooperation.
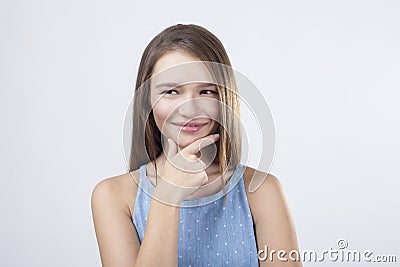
[243,167,302,267]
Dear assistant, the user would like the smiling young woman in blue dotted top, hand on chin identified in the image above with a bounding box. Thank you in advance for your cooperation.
[92,24,301,267]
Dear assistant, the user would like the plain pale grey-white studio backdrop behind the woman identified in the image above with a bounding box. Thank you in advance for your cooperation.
[0,0,400,266]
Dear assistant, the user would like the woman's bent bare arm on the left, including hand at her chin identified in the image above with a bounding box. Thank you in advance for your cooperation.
[92,136,218,267]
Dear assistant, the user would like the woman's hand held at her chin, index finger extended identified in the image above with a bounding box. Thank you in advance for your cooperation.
[153,134,219,206]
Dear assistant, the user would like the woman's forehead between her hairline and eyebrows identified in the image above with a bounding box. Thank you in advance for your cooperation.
[151,51,213,84]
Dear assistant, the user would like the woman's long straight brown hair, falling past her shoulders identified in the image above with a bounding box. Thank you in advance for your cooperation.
[129,24,241,192]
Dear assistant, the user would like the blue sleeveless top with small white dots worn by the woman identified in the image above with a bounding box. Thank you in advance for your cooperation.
[132,164,258,267]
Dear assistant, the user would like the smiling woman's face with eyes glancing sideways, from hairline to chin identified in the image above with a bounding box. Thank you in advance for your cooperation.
[150,51,221,148]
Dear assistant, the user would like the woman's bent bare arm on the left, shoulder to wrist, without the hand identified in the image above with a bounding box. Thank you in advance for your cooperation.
[92,177,179,267]
